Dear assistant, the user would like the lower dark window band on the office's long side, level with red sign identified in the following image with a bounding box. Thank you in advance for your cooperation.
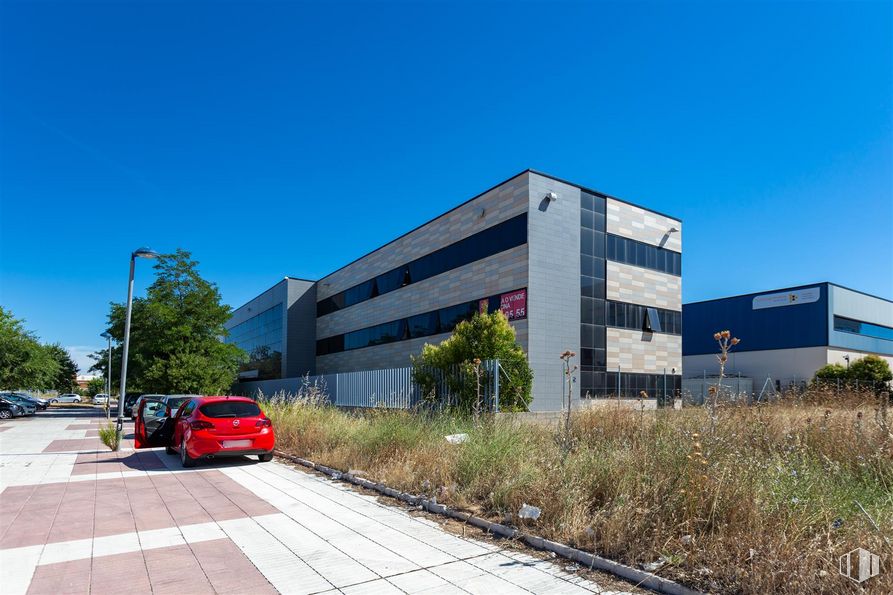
[316,289,526,355]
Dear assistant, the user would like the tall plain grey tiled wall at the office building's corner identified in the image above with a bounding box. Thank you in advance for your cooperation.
[527,173,580,411]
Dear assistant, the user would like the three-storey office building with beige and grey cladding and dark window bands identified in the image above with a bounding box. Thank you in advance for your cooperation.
[227,170,682,411]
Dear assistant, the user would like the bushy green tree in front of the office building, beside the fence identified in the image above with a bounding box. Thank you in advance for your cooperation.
[413,311,533,411]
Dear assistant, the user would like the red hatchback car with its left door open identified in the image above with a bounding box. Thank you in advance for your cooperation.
[134,397,276,467]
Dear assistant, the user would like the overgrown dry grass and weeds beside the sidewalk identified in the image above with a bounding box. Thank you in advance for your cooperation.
[266,396,893,593]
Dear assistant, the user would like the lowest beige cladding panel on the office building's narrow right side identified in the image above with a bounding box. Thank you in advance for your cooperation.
[607,327,682,374]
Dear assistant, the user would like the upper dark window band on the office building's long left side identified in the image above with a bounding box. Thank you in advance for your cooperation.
[316,213,527,316]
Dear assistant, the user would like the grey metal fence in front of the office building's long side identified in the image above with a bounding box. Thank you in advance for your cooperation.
[233,360,505,411]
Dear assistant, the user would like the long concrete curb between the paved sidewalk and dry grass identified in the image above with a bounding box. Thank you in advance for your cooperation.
[273,450,703,595]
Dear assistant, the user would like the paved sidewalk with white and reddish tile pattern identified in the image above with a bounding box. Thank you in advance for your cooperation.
[0,408,637,595]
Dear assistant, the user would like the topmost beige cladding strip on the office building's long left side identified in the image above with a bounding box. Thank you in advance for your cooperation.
[317,172,528,300]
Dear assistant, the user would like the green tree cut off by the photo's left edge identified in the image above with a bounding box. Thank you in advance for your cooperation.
[0,306,59,390]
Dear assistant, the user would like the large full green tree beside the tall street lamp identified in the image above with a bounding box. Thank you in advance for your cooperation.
[90,249,245,394]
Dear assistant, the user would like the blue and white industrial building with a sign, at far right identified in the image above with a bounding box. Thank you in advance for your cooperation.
[682,283,893,389]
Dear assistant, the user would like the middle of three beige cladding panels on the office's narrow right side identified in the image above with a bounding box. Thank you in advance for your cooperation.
[605,260,682,312]
